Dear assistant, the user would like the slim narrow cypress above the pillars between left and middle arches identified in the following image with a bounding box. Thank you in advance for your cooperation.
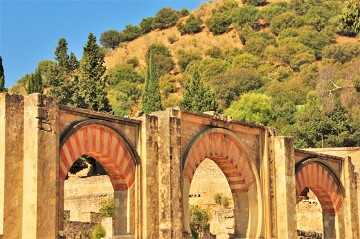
[141,55,162,113]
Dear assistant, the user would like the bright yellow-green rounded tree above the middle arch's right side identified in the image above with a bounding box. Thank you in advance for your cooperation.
[225,93,273,125]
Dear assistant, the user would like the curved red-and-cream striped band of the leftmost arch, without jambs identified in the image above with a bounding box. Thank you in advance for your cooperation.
[59,119,139,191]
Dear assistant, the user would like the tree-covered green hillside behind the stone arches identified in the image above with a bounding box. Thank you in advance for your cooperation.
[12,0,360,147]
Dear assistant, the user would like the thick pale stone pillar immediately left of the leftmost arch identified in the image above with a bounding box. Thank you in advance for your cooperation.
[22,94,59,239]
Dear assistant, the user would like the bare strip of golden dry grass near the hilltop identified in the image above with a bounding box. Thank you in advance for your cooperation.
[105,0,242,73]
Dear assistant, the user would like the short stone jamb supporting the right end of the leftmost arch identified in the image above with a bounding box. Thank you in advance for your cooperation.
[113,190,130,239]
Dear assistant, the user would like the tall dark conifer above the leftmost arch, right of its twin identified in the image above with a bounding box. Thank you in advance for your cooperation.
[74,33,111,112]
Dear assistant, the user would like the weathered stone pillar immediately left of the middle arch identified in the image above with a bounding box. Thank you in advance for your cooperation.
[155,109,183,239]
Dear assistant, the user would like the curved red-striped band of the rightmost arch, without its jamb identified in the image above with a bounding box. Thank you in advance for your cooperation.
[295,158,344,214]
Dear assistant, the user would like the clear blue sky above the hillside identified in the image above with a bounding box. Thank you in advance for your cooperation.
[0,0,204,88]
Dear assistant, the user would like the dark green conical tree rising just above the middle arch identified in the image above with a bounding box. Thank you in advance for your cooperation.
[180,69,217,112]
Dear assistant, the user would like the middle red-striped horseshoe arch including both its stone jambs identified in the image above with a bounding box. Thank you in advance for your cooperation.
[182,128,262,238]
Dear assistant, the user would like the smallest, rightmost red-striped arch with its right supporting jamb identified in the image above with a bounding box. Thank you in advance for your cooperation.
[296,160,343,238]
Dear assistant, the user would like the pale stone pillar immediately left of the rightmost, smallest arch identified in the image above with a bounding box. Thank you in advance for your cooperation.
[274,136,297,239]
